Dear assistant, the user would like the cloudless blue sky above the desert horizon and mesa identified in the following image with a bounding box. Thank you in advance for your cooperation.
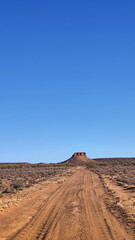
[0,0,135,162]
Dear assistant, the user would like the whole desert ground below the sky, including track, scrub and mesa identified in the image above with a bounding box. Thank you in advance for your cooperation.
[0,153,135,240]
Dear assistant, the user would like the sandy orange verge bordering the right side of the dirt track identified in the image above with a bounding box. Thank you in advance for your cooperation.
[101,175,135,233]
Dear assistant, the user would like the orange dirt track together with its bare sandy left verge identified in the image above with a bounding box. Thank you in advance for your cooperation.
[0,168,134,240]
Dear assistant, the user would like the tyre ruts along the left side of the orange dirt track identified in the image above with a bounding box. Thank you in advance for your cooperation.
[9,177,71,240]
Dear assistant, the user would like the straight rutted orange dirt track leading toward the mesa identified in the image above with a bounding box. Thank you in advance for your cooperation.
[8,168,134,240]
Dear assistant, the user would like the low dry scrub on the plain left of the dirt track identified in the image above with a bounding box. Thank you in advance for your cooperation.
[0,164,71,196]
